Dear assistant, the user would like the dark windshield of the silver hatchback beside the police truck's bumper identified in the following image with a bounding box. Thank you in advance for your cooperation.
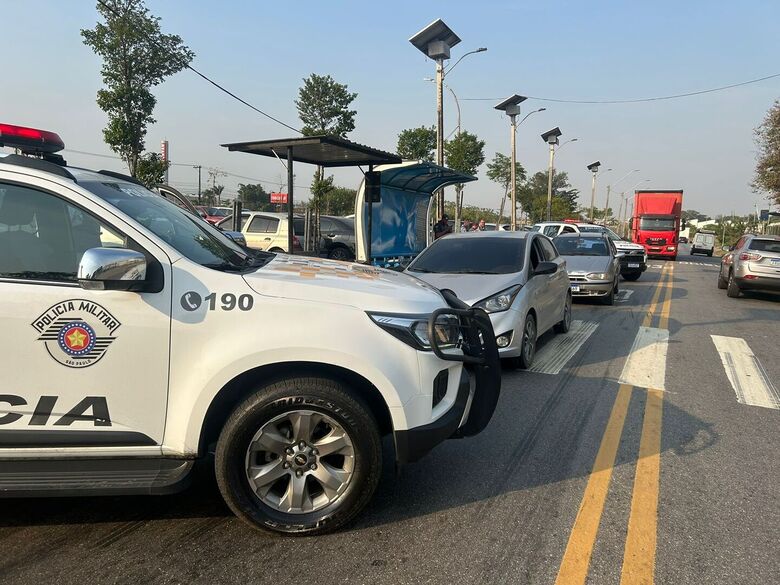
[409,237,525,274]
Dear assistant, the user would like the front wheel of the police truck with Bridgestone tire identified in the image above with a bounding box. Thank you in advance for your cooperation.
[215,378,382,535]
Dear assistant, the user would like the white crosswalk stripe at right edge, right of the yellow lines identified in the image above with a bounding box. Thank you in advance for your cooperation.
[710,335,780,410]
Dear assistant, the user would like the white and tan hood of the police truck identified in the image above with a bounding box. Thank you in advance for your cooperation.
[244,254,445,313]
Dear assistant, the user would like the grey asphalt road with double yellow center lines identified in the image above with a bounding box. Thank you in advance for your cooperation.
[0,249,780,585]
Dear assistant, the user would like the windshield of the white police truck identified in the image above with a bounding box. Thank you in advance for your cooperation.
[79,181,249,270]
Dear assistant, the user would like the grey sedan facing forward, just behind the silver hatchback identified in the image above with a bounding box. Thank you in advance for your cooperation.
[553,232,620,305]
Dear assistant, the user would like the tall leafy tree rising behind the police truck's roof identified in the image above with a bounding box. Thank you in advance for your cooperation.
[81,0,195,177]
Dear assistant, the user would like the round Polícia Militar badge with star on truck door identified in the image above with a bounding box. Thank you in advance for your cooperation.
[31,299,121,368]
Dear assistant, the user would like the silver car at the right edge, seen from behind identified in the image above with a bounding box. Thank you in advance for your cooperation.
[718,234,780,298]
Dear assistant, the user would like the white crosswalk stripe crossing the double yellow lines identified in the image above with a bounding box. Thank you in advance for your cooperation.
[618,327,669,390]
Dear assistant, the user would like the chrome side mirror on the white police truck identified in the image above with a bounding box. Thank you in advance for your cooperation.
[77,248,147,292]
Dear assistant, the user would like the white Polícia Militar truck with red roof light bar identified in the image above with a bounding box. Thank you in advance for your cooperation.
[0,124,500,534]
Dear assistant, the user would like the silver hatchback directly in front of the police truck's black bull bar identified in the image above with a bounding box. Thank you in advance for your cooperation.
[406,230,571,368]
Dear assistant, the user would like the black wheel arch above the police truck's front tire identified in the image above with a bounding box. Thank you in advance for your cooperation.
[198,361,393,456]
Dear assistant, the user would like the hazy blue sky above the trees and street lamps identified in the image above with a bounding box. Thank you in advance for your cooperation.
[0,0,780,215]
